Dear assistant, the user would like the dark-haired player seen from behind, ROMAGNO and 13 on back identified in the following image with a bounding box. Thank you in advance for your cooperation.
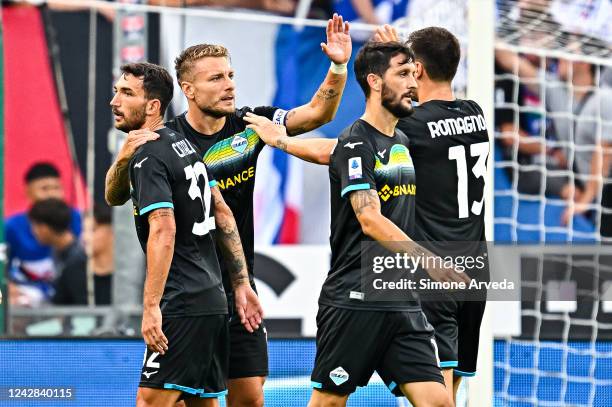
[377,26,489,404]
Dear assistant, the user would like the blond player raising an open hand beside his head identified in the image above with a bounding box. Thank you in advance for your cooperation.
[106,15,351,407]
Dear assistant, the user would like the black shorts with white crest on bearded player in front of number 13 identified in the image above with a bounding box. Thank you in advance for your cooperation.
[311,305,444,396]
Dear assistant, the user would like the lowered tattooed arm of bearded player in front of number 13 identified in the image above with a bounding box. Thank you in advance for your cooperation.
[349,189,470,283]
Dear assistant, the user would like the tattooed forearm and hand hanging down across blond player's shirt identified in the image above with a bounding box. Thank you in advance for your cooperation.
[211,187,263,332]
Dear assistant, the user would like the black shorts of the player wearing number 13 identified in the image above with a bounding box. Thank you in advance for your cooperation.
[421,301,487,376]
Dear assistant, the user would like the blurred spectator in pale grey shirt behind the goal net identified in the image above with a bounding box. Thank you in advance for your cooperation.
[498,41,612,236]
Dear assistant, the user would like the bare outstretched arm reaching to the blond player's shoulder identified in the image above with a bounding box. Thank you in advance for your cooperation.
[244,112,338,165]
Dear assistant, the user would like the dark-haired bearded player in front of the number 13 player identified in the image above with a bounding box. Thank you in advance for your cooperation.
[246,42,469,407]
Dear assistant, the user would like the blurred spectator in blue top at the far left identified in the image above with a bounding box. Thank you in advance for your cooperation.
[4,163,81,306]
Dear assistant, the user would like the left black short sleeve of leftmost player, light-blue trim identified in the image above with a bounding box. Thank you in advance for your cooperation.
[130,152,174,215]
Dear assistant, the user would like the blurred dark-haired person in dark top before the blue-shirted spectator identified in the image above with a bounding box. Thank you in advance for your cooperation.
[29,198,87,305]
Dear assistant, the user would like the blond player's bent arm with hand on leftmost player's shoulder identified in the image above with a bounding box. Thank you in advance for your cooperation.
[104,129,159,206]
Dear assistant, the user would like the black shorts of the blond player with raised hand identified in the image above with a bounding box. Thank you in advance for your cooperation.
[227,294,268,379]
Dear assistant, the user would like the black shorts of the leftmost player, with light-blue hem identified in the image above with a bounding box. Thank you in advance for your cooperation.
[139,315,229,398]
